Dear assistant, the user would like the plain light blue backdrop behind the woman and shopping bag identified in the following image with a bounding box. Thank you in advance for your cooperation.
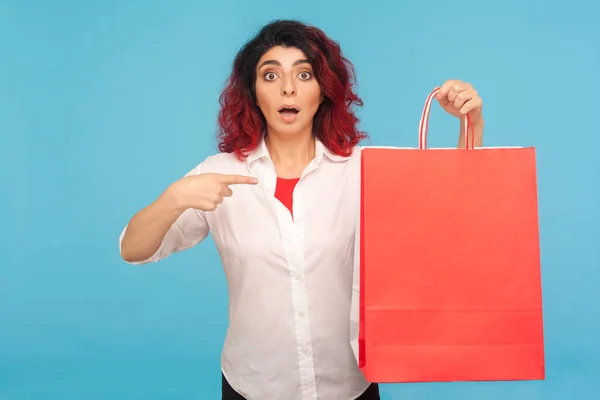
[0,0,600,400]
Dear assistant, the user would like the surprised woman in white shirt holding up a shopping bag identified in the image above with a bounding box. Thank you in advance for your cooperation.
[121,17,483,400]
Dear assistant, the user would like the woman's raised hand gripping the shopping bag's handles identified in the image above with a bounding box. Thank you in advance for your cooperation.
[436,80,483,125]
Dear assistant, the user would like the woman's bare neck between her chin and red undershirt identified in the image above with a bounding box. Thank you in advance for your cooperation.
[265,131,315,178]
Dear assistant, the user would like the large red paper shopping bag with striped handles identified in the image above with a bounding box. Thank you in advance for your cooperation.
[358,89,545,382]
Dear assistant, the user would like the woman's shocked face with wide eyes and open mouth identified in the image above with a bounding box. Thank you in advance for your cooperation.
[255,46,322,135]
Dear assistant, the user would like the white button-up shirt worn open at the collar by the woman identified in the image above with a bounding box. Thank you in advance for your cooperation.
[121,141,369,400]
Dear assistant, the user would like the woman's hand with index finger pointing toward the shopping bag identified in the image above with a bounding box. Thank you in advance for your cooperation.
[170,173,258,212]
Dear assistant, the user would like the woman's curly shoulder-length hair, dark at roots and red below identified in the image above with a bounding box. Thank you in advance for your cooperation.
[218,20,367,158]
